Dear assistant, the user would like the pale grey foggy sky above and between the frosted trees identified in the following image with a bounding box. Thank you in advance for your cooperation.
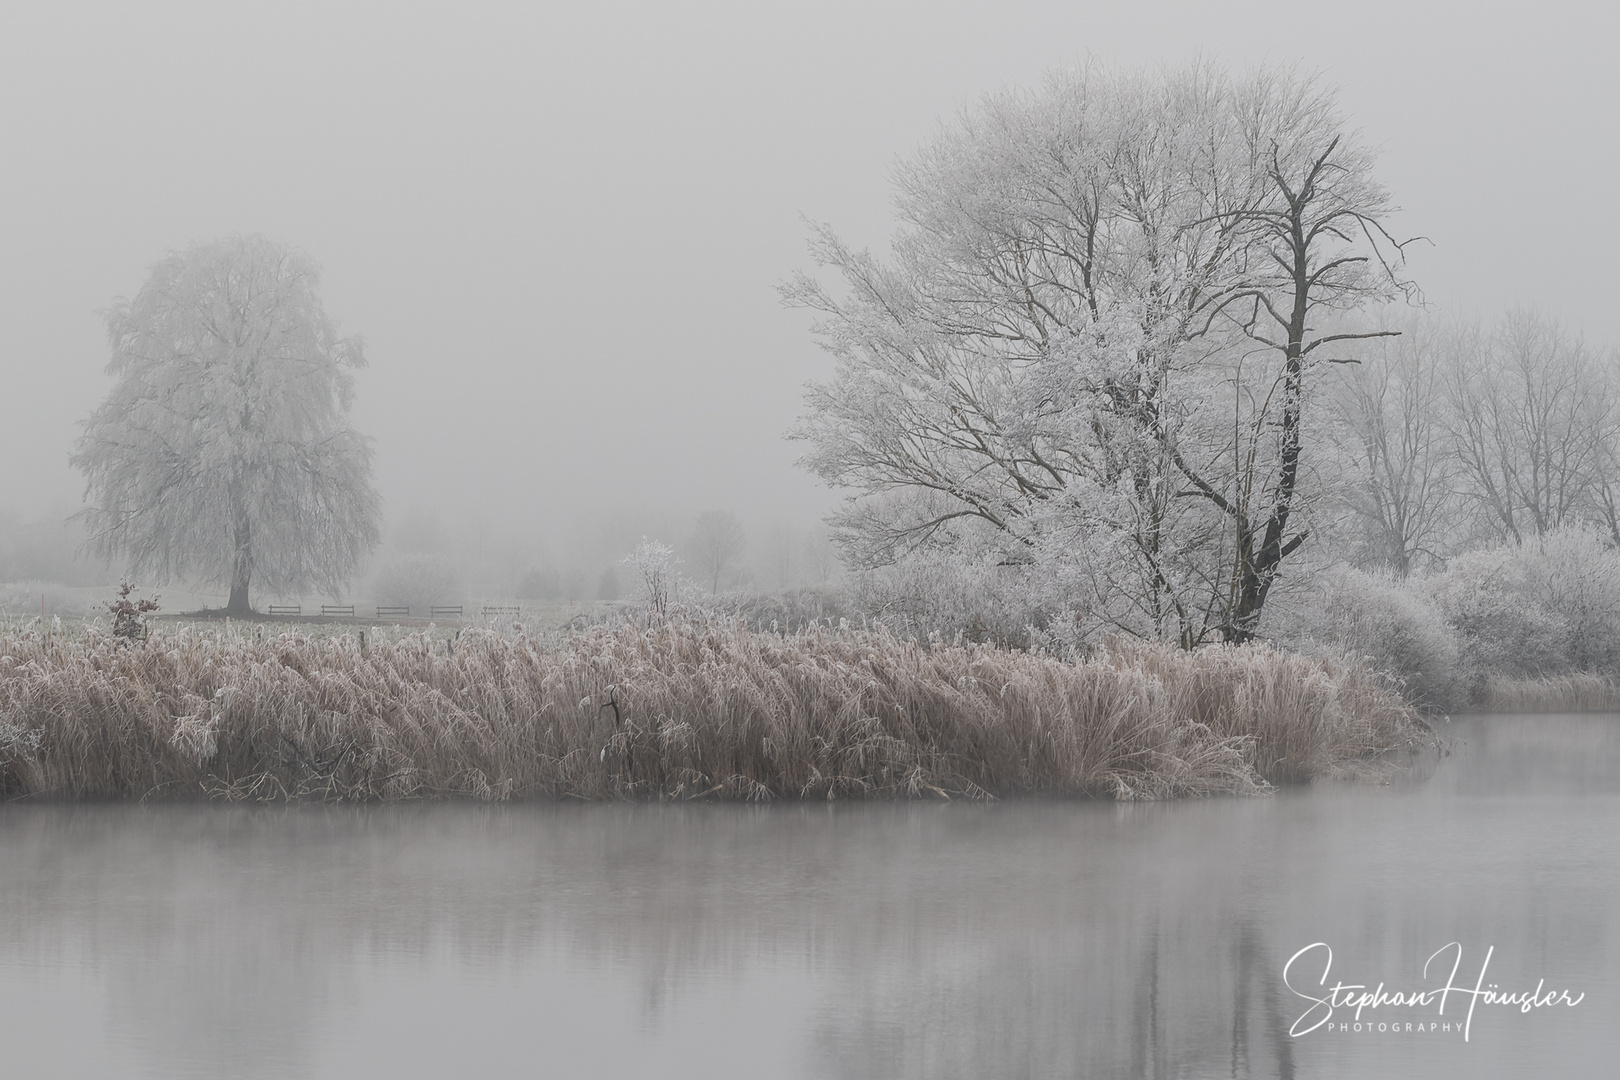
[0,0,1620,537]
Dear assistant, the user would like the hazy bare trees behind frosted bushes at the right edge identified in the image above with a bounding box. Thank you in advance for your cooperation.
[1332,311,1620,576]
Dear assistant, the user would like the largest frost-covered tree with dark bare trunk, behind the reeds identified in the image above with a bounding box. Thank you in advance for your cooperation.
[786,66,1403,644]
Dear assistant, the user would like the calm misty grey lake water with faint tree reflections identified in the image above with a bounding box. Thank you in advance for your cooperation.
[0,716,1620,1080]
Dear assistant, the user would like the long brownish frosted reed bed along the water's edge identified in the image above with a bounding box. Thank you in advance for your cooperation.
[0,619,1426,800]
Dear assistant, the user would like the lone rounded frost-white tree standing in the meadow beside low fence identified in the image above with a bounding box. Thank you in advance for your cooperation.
[71,236,379,614]
